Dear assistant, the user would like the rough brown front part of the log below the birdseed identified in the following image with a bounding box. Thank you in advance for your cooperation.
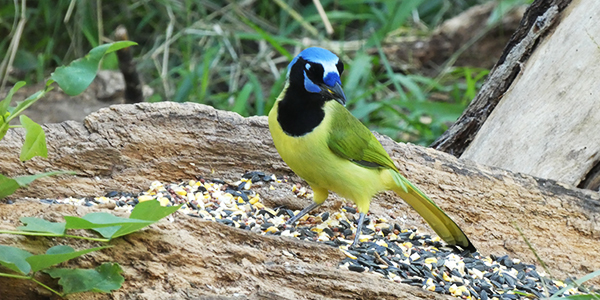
[0,202,460,300]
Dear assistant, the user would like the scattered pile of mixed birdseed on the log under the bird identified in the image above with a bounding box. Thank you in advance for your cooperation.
[41,172,589,300]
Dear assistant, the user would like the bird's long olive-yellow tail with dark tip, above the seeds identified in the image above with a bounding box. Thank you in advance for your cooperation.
[390,170,477,252]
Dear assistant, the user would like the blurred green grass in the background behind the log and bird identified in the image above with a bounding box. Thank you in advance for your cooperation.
[0,0,530,145]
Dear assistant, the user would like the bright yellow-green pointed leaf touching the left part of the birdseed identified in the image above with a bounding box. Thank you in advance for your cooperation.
[112,201,181,238]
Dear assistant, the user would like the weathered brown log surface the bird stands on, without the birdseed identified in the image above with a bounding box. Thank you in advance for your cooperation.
[0,102,600,299]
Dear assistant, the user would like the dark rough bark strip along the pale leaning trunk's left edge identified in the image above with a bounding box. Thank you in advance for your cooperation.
[431,0,571,156]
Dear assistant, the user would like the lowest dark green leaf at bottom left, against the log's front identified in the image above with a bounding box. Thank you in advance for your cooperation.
[44,263,125,294]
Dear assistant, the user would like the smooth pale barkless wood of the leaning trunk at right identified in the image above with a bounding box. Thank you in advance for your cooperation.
[461,0,600,185]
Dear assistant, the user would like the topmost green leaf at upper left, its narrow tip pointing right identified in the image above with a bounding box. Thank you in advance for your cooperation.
[50,41,137,96]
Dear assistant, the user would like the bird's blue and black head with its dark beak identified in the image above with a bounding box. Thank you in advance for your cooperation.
[288,47,346,105]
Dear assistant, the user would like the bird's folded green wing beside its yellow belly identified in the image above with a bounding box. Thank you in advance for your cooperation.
[327,103,398,171]
